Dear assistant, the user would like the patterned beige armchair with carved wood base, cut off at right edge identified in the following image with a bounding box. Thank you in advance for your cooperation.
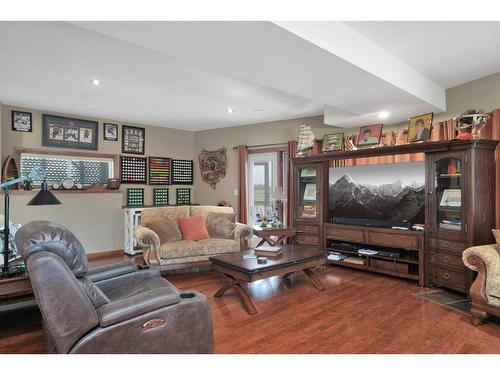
[462,236,500,325]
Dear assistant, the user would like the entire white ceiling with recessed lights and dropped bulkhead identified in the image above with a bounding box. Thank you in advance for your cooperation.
[0,21,500,130]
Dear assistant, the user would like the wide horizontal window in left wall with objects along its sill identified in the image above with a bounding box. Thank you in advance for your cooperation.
[19,152,115,186]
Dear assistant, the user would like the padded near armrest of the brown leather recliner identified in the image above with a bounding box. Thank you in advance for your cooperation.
[97,288,180,327]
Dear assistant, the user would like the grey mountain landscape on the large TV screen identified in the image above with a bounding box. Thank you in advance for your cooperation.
[329,166,425,224]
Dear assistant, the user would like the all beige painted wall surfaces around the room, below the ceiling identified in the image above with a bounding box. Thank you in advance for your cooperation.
[0,73,500,251]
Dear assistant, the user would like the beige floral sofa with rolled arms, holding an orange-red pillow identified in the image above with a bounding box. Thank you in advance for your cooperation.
[134,206,252,269]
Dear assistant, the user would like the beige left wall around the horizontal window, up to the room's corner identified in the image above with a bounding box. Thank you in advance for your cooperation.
[0,105,195,252]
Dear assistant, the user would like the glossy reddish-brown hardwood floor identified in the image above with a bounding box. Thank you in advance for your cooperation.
[0,267,500,353]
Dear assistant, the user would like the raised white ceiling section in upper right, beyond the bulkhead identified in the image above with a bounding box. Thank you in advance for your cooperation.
[345,21,500,88]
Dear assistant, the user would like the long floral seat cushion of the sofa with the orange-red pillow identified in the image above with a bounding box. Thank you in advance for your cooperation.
[160,238,240,260]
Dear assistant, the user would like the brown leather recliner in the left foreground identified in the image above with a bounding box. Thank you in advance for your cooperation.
[16,221,213,353]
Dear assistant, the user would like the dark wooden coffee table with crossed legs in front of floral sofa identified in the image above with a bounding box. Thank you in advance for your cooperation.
[210,245,326,315]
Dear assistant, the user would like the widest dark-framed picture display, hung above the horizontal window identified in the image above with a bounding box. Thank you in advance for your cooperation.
[42,114,99,151]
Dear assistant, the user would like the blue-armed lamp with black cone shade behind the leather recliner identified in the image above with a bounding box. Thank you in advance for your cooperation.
[0,168,61,276]
